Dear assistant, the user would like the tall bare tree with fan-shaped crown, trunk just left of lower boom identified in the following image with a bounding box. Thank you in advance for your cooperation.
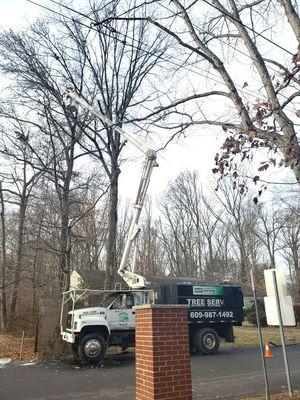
[65,1,164,288]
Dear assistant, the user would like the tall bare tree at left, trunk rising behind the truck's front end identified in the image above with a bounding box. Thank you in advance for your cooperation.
[0,16,110,288]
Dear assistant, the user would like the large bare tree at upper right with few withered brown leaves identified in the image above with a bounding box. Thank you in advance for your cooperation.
[107,0,300,183]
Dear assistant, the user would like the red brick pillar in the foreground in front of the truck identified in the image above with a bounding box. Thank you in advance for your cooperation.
[135,304,193,400]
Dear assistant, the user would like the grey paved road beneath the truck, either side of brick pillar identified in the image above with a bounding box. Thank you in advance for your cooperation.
[0,345,300,400]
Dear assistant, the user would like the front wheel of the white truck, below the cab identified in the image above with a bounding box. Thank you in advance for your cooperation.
[78,333,107,364]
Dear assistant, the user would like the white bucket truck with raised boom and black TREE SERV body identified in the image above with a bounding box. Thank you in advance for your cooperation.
[60,89,244,364]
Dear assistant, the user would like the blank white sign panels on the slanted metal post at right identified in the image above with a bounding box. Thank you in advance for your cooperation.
[264,268,296,326]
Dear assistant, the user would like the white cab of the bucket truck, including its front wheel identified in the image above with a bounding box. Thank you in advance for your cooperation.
[60,289,154,364]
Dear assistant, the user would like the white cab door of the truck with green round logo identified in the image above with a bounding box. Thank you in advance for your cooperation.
[107,293,135,330]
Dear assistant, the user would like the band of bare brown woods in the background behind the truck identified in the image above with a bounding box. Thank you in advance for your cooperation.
[1,166,300,327]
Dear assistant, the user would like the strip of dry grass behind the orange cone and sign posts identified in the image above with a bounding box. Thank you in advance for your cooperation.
[222,323,300,348]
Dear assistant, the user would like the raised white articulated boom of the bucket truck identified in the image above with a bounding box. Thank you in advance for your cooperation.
[63,89,158,289]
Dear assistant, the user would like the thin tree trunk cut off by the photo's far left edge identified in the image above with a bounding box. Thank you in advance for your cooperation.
[0,182,7,329]
